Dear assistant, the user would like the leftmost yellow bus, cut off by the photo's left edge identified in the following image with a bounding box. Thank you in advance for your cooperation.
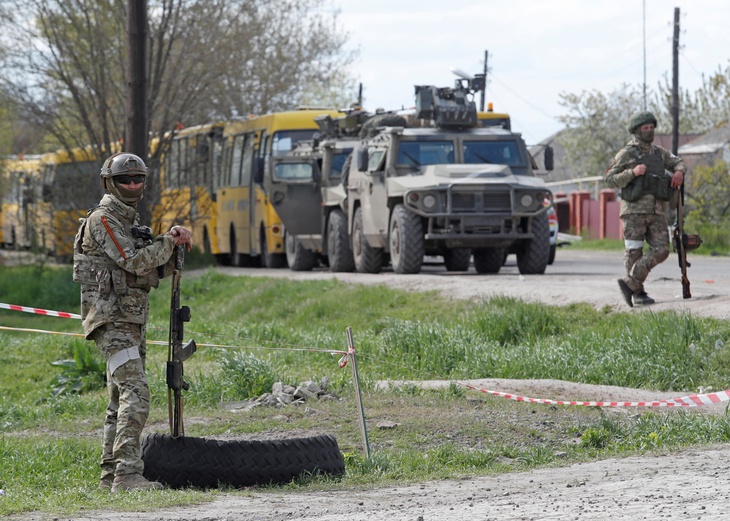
[0,155,41,250]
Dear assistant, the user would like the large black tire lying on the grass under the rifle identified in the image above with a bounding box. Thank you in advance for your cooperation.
[142,433,345,488]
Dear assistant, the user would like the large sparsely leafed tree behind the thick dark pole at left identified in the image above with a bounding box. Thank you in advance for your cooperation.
[0,0,354,157]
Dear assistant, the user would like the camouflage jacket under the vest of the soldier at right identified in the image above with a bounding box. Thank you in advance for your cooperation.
[605,138,687,216]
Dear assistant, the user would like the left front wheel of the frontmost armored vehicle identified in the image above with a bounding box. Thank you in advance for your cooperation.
[388,204,426,274]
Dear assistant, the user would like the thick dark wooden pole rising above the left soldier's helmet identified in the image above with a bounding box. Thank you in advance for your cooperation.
[124,0,147,161]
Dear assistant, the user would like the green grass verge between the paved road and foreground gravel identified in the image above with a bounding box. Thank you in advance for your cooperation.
[0,266,730,515]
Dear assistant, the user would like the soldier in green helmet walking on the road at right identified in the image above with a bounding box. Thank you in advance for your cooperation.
[606,112,687,307]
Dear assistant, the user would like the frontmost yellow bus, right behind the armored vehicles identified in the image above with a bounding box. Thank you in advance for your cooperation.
[215,109,339,268]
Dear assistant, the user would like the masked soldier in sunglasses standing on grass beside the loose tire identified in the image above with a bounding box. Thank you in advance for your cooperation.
[73,153,191,492]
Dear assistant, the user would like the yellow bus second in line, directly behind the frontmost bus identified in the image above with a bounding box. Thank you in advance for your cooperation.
[151,122,226,255]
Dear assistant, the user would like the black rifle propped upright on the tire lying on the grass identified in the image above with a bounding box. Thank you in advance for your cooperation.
[167,245,197,438]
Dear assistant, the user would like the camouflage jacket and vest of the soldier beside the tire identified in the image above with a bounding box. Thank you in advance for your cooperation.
[73,194,175,338]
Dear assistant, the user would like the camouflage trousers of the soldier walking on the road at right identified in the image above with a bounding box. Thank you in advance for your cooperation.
[621,213,669,293]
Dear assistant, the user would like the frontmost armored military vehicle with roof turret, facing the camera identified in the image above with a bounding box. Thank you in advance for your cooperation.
[344,80,552,274]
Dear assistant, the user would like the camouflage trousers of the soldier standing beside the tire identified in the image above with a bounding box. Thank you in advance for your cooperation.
[91,322,150,478]
